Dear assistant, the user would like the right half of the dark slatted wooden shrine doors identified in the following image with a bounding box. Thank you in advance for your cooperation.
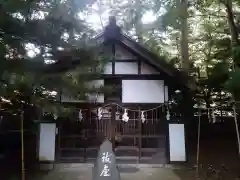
[115,106,166,164]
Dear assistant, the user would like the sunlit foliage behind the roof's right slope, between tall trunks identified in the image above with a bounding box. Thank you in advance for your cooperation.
[80,0,240,108]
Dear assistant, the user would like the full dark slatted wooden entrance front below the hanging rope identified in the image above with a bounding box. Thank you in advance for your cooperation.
[57,104,167,164]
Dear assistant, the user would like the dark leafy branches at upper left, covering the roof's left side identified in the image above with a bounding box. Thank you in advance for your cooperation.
[0,0,105,115]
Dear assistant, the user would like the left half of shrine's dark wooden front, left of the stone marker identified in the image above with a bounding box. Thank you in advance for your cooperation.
[58,106,112,163]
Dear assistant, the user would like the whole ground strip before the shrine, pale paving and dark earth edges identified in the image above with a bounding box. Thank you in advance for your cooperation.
[1,150,239,180]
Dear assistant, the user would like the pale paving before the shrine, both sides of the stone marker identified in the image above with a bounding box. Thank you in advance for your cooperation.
[34,164,193,180]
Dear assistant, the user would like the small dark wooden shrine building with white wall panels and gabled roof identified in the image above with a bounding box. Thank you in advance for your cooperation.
[38,18,194,164]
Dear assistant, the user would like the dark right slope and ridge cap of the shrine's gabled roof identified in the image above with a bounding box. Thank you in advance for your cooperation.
[95,17,195,90]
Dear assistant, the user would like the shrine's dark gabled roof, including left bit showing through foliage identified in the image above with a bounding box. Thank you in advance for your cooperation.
[44,17,196,90]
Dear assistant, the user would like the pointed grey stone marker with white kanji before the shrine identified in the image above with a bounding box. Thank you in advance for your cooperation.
[93,140,120,180]
